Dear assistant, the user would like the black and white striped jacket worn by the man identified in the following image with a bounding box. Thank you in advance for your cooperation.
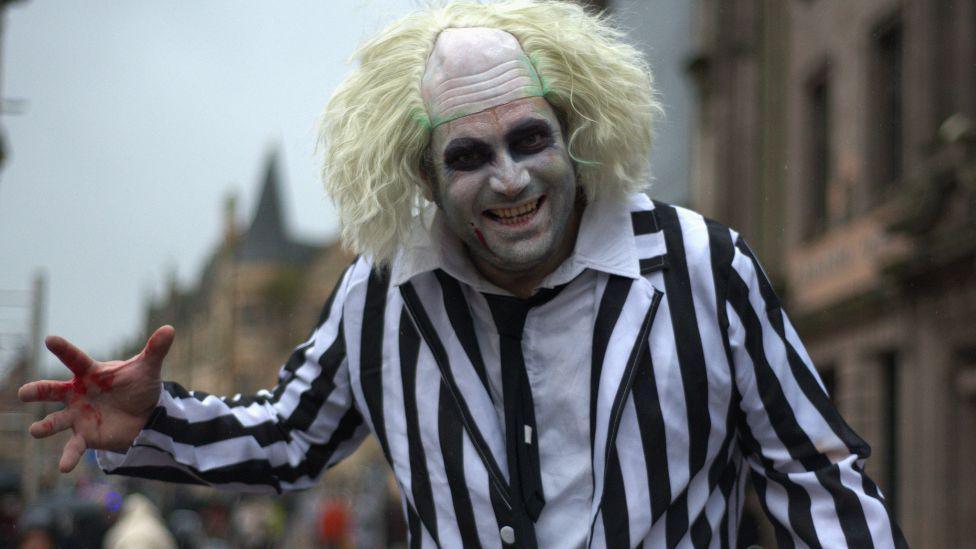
[99,196,904,547]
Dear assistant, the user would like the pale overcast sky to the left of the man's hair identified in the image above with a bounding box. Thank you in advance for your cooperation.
[0,0,692,376]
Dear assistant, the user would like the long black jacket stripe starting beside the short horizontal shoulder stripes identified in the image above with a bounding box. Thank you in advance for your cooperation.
[654,202,712,476]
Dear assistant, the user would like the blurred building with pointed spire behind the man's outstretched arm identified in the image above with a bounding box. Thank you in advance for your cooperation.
[137,155,395,535]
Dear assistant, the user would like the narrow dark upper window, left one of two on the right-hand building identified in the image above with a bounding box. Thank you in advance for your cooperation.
[805,65,831,237]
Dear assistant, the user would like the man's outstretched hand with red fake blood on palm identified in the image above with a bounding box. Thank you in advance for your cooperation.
[17,326,176,473]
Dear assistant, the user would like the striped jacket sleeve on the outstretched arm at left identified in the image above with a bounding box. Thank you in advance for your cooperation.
[96,262,367,492]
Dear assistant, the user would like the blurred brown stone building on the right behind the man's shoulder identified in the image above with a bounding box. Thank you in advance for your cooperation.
[689,0,976,547]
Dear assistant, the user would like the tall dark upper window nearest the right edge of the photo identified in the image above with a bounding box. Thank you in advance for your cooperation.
[868,11,904,198]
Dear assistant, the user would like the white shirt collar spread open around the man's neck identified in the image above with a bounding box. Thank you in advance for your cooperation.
[391,196,641,294]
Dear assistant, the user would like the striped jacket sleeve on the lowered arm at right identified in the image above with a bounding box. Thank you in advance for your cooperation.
[726,238,907,547]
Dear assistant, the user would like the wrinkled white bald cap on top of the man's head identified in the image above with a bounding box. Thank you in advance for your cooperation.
[420,27,545,127]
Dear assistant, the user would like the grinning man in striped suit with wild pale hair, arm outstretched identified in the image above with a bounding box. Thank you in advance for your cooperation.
[21,1,904,547]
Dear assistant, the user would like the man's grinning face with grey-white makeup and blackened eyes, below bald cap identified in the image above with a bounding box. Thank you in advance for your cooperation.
[429,97,577,274]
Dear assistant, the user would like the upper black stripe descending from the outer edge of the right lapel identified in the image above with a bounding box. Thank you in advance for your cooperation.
[633,330,671,524]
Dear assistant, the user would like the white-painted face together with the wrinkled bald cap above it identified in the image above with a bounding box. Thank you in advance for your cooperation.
[422,28,579,287]
